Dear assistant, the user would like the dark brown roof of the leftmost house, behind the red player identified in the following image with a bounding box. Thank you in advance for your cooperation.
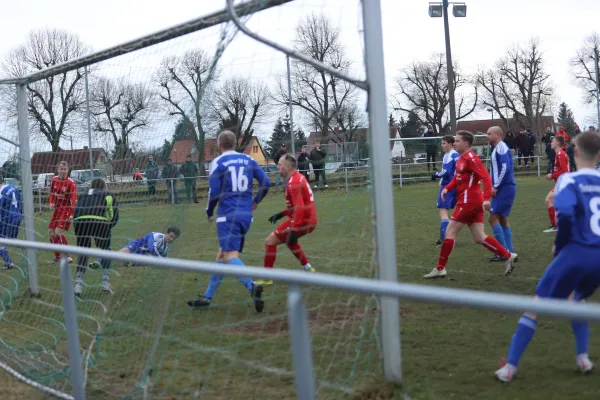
[31,147,108,175]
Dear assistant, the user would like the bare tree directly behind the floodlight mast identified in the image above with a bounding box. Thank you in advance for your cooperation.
[396,54,478,134]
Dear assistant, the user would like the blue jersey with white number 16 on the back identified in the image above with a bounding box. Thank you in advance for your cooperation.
[206,150,271,217]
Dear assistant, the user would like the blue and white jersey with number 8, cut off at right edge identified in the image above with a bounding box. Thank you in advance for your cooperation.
[554,168,600,248]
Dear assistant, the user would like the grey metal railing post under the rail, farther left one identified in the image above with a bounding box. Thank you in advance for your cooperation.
[60,254,85,400]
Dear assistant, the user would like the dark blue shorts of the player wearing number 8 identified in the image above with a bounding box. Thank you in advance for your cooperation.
[535,244,600,300]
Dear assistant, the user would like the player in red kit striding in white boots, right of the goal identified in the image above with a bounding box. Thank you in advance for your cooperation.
[423,131,517,279]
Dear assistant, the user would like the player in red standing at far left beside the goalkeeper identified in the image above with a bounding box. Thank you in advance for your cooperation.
[48,161,77,264]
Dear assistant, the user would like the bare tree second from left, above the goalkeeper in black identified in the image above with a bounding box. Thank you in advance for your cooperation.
[90,78,156,172]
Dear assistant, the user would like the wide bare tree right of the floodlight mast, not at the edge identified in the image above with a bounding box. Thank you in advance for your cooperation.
[476,39,553,130]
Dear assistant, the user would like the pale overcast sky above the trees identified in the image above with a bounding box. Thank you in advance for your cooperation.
[0,0,600,158]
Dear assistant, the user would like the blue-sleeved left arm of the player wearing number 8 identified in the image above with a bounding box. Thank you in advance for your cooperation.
[554,175,577,254]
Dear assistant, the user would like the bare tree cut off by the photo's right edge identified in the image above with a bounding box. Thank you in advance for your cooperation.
[571,33,600,103]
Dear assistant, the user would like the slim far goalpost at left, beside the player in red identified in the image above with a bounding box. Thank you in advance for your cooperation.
[16,85,40,296]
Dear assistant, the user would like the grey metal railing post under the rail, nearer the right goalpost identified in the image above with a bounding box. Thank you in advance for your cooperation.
[288,285,316,400]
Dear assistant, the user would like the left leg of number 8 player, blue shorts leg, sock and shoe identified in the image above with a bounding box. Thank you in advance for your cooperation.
[496,250,581,382]
